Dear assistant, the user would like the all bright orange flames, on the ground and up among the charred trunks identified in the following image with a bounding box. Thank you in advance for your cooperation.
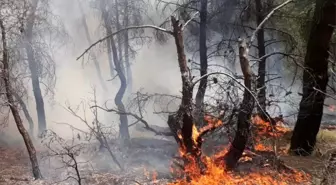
[170,117,309,185]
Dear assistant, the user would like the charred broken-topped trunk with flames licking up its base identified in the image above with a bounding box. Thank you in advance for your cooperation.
[169,16,205,172]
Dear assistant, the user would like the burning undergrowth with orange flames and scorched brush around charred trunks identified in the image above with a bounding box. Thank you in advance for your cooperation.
[170,116,310,185]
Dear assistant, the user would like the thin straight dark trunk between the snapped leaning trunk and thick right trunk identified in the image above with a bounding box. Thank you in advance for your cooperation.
[255,0,267,112]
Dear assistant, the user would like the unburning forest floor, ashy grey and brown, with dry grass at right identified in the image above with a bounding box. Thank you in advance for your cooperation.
[0,130,336,185]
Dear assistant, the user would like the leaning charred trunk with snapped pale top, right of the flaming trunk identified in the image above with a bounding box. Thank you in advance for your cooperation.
[224,40,254,169]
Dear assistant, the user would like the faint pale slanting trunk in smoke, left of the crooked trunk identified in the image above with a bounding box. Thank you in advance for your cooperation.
[78,1,107,91]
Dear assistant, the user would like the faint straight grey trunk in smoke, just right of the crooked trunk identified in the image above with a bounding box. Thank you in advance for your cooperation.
[124,0,133,94]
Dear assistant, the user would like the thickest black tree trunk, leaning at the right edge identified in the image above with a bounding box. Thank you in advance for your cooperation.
[290,0,336,155]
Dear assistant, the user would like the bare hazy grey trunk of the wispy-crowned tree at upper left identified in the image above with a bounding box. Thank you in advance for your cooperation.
[24,0,47,136]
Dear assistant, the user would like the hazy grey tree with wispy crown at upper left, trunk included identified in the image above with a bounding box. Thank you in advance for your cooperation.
[3,0,66,137]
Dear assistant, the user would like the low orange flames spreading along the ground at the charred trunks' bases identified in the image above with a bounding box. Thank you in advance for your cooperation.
[169,151,310,185]
